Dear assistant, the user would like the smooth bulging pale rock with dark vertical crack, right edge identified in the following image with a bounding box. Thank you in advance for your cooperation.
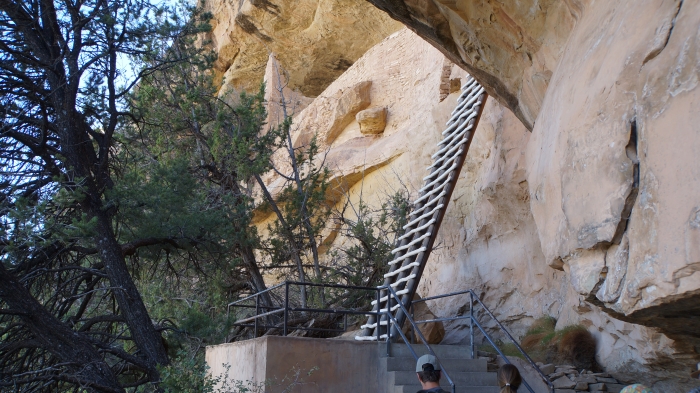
[527,1,700,345]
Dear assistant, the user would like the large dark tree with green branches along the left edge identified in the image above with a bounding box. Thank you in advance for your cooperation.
[0,0,221,391]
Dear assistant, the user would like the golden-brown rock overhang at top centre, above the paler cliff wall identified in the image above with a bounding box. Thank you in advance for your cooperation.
[205,0,401,97]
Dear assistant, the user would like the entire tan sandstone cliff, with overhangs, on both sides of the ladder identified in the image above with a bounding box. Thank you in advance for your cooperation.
[212,0,700,393]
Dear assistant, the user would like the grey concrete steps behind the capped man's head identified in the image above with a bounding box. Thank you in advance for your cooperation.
[379,344,500,393]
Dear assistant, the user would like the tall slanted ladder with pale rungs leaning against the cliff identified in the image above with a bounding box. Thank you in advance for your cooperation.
[355,76,487,341]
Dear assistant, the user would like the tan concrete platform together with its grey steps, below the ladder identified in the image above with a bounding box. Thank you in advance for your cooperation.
[206,336,499,393]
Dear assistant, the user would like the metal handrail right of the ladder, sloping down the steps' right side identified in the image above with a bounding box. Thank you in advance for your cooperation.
[410,289,554,393]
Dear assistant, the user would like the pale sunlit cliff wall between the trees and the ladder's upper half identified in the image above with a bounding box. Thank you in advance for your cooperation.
[260,29,464,214]
